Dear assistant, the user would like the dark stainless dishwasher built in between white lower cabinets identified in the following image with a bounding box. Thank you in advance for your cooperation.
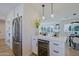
[38,39,49,56]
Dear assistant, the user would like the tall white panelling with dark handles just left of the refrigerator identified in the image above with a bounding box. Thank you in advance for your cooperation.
[5,10,14,49]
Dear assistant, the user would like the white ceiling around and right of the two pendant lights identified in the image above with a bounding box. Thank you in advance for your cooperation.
[38,3,79,22]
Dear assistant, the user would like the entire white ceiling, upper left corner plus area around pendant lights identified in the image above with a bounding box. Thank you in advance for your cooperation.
[0,3,79,19]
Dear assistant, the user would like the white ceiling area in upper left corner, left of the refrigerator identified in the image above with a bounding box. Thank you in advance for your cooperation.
[0,3,18,19]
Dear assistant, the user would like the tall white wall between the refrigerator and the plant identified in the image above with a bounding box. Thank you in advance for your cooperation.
[22,4,40,55]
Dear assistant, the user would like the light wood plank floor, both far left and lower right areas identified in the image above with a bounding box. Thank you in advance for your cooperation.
[0,39,79,56]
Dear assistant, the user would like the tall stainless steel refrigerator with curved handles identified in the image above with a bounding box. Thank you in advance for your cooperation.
[12,16,22,56]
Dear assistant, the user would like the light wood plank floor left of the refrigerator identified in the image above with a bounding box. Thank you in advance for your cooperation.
[0,39,13,56]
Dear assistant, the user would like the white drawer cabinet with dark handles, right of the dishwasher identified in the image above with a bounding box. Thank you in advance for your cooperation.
[49,40,65,56]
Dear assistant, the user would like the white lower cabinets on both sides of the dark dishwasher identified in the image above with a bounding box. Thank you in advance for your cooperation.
[32,38,66,56]
